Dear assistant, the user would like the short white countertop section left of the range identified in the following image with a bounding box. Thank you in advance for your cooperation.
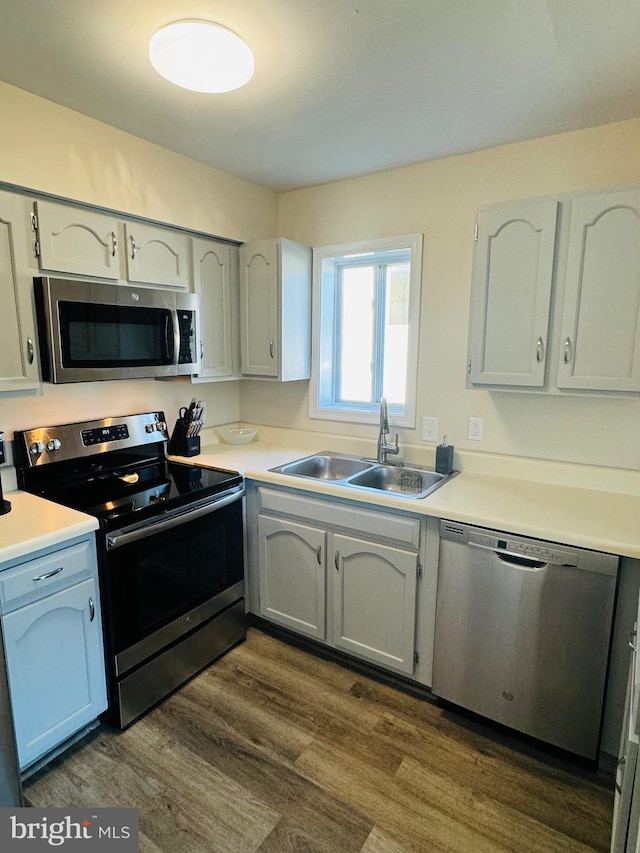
[0,492,98,563]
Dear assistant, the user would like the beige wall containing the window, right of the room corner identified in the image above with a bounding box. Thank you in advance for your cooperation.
[240,120,640,468]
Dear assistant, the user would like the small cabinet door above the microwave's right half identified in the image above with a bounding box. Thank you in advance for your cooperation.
[124,222,189,289]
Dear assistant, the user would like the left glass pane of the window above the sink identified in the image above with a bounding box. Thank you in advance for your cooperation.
[335,266,375,403]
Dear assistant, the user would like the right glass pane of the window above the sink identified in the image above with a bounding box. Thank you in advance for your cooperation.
[382,263,410,405]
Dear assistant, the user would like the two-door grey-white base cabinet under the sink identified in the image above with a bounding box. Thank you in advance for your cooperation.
[249,487,435,683]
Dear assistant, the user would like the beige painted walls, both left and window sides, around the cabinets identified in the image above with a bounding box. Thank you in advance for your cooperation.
[0,83,640,469]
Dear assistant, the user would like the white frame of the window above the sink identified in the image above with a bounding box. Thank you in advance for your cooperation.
[309,234,422,428]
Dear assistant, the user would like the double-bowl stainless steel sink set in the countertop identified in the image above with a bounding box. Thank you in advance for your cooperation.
[271,450,458,500]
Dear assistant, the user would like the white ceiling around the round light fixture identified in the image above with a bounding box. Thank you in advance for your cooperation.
[0,0,640,190]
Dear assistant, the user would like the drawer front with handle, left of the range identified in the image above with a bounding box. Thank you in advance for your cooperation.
[0,540,96,613]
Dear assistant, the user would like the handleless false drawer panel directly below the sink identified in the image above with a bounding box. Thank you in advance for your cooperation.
[258,487,420,549]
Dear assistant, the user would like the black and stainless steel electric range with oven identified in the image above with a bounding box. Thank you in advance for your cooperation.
[15,412,246,728]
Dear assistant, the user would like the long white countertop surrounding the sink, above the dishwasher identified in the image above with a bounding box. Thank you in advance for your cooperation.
[176,438,640,559]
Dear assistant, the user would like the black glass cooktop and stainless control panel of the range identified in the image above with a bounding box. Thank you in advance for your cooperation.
[15,412,242,529]
